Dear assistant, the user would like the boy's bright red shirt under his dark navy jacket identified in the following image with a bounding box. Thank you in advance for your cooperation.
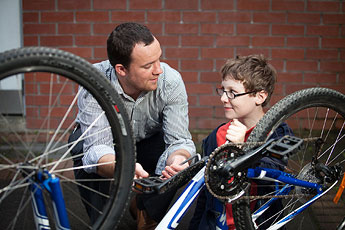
[216,120,255,230]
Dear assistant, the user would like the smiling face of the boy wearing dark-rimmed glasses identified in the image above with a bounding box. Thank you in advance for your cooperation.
[220,77,257,120]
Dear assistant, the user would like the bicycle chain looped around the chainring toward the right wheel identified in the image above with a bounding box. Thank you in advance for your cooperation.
[205,137,319,202]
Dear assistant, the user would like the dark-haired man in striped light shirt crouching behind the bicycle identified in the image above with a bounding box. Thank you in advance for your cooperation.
[71,23,195,229]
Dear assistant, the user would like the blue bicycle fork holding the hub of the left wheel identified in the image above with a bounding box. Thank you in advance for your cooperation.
[30,171,70,230]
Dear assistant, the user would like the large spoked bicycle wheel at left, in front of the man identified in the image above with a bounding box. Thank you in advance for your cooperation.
[0,47,135,229]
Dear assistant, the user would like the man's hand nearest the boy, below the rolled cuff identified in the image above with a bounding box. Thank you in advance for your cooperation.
[162,150,190,179]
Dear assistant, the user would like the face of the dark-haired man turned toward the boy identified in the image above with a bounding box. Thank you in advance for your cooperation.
[124,38,163,97]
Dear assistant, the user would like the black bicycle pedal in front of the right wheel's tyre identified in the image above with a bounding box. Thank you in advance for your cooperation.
[267,136,303,159]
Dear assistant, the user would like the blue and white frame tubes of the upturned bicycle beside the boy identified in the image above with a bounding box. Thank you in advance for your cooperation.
[156,167,337,230]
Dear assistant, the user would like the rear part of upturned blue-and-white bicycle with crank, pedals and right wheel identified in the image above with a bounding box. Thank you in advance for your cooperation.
[135,88,345,229]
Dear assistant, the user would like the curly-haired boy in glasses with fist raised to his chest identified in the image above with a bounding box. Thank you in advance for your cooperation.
[189,55,290,229]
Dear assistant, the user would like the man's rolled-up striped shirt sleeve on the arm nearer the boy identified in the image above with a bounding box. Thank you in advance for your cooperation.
[156,69,195,175]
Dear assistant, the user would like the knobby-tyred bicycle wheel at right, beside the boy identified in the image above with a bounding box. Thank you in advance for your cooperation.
[233,88,345,230]
